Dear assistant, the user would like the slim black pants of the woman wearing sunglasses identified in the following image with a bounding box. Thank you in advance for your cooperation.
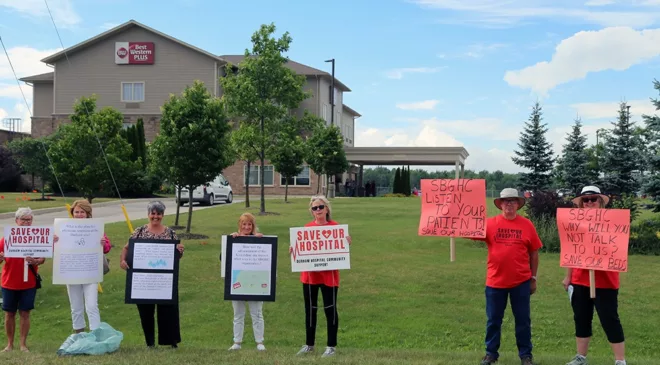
[303,284,339,347]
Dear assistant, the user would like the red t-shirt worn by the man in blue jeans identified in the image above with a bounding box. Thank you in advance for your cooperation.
[479,214,543,289]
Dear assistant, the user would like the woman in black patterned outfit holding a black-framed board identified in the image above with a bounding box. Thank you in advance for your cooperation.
[119,201,184,348]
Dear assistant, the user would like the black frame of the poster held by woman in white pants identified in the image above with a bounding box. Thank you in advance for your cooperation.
[222,235,277,302]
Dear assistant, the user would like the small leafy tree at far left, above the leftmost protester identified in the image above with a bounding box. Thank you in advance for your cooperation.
[7,137,54,200]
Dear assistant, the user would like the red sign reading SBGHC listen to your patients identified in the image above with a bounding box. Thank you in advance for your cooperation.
[418,179,486,237]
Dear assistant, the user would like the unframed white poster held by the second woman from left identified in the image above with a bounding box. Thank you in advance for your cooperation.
[53,218,104,285]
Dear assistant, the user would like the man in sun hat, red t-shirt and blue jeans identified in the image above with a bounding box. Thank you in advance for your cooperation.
[479,188,543,365]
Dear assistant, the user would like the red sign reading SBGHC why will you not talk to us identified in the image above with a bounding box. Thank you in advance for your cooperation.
[557,208,630,272]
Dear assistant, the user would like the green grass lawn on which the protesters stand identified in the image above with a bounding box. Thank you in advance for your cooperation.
[0,198,660,365]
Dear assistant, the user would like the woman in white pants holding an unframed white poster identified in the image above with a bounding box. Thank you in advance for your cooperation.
[53,200,112,333]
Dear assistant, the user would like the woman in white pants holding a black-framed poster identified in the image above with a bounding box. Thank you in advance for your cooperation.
[229,213,266,351]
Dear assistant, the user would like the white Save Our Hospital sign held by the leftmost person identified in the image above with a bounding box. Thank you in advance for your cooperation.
[5,226,53,258]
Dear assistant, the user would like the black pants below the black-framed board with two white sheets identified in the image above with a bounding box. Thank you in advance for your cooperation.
[137,304,181,346]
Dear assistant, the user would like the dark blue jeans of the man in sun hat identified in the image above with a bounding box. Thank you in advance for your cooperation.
[486,281,532,359]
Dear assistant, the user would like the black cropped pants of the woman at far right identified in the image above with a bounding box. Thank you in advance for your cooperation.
[571,285,624,343]
